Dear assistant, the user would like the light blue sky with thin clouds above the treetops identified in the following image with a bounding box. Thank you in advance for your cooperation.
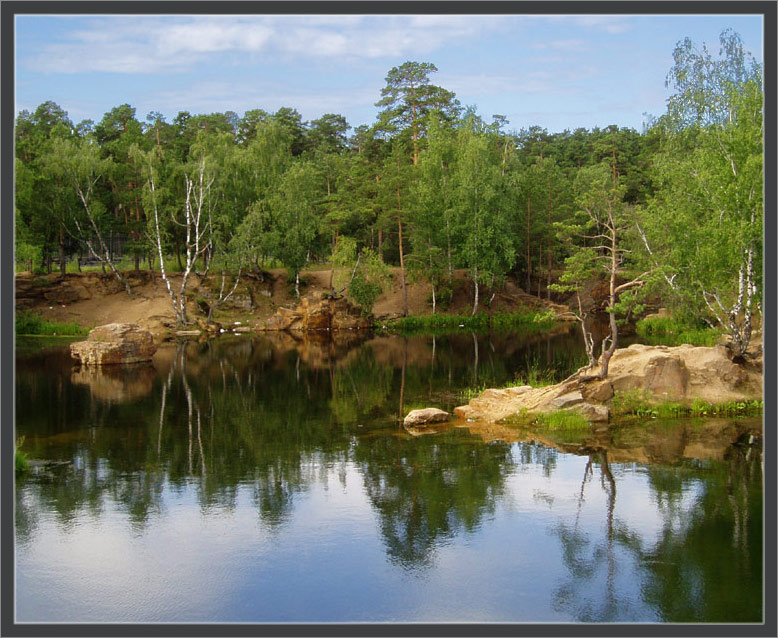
[15,15,763,132]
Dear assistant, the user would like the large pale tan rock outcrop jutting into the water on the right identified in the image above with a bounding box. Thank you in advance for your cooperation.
[454,344,762,422]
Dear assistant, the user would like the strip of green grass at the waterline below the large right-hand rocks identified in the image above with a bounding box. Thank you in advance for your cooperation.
[611,390,764,419]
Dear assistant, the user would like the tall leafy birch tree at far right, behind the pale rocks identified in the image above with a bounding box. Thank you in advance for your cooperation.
[641,31,764,361]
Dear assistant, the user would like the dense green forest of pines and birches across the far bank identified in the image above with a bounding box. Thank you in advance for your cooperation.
[15,30,763,366]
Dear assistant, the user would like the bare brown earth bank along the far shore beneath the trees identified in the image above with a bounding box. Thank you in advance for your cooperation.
[15,268,566,339]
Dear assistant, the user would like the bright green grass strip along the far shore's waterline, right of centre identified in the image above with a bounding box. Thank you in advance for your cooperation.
[374,311,556,334]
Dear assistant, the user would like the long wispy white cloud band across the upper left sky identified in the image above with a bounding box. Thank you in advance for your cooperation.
[18,15,503,73]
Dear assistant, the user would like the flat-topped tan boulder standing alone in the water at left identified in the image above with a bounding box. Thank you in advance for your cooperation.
[70,323,157,365]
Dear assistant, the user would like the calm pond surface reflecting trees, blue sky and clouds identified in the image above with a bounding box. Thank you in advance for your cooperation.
[16,333,762,622]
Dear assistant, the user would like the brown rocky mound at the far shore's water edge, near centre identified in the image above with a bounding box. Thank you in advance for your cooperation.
[258,292,370,332]
